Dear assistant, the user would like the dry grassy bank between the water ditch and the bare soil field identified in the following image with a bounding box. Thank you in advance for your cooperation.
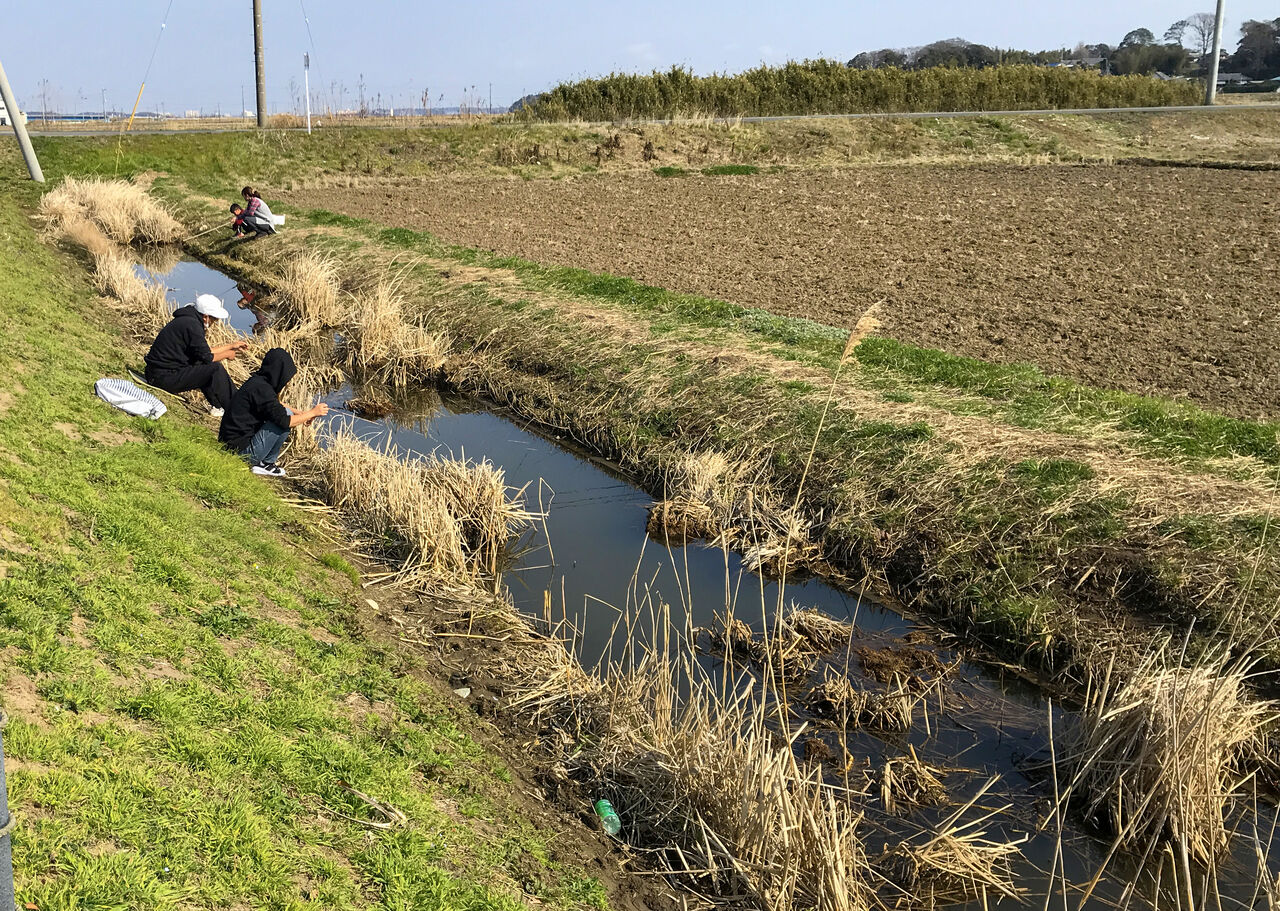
[12,126,1280,685]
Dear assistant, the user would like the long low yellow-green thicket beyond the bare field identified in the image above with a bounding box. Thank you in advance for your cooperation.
[518,60,1201,120]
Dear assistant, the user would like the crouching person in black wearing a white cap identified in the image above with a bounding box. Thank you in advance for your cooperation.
[143,294,248,417]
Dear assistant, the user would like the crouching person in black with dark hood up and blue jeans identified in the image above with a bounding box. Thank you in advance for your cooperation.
[218,348,329,477]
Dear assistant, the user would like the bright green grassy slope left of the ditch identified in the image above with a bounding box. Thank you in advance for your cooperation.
[0,195,619,911]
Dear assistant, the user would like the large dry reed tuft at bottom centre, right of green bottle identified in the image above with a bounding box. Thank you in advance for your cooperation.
[513,639,870,911]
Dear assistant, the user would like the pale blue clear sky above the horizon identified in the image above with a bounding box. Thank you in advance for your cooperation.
[0,0,1280,113]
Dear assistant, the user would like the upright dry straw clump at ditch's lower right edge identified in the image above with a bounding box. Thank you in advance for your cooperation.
[1070,649,1275,862]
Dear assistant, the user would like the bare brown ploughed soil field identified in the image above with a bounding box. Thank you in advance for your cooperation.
[282,164,1280,417]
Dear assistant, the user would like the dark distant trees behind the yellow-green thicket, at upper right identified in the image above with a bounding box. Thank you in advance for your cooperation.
[847,13,1280,79]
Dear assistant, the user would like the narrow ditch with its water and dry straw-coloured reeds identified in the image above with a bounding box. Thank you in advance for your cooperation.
[37,179,1276,910]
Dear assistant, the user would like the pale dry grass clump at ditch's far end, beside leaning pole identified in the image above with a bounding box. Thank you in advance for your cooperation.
[40,177,183,244]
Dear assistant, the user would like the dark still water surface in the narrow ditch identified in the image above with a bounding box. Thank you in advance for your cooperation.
[137,254,1280,907]
